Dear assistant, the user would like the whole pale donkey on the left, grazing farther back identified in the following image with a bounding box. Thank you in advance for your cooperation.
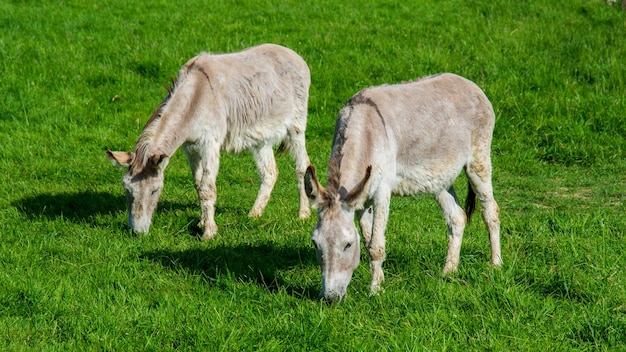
[107,44,311,240]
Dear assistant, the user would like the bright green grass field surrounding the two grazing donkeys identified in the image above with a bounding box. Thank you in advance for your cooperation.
[0,0,626,351]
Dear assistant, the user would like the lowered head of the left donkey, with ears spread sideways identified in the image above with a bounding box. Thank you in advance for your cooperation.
[107,151,169,233]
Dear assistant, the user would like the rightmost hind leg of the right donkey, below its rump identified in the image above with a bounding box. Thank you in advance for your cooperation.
[465,156,502,266]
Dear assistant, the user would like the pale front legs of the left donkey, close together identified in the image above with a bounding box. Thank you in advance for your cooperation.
[183,146,220,240]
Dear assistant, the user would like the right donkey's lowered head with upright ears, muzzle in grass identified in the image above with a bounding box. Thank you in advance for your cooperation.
[305,166,372,301]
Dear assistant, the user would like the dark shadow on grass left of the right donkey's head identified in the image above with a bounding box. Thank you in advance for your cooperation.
[140,244,319,300]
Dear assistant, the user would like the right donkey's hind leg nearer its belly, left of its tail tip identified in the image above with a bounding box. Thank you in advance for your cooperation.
[435,186,467,275]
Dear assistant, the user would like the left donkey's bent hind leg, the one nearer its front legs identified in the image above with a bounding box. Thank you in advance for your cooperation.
[248,144,278,217]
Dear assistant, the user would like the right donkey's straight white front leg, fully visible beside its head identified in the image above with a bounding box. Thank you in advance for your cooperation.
[366,190,391,294]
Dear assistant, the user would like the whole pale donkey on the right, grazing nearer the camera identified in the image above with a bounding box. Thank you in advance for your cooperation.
[305,73,502,301]
